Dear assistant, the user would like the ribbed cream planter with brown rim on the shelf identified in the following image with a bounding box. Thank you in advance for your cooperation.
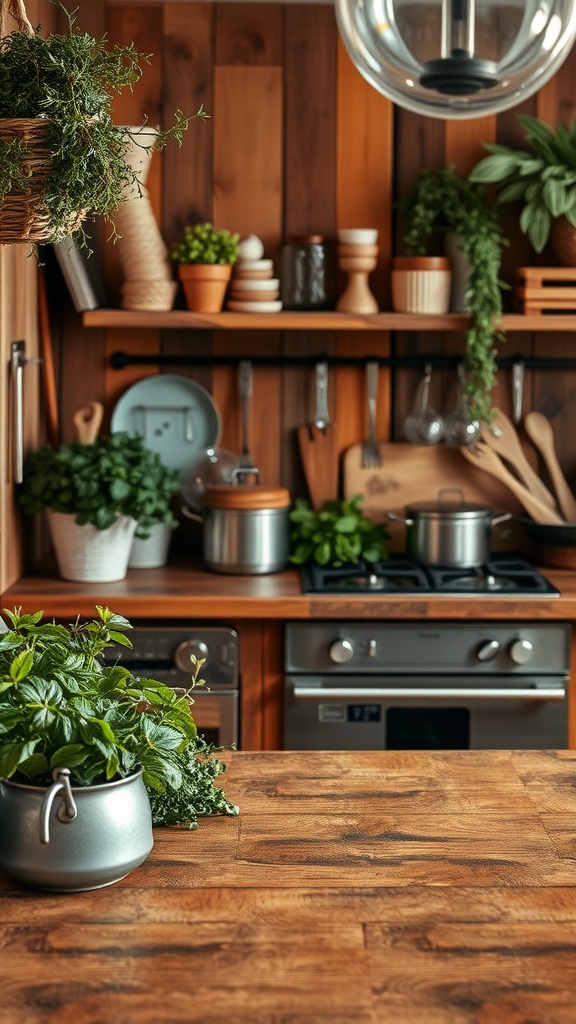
[392,256,452,313]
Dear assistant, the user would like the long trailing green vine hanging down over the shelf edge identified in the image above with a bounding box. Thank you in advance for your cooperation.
[399,165,508,422]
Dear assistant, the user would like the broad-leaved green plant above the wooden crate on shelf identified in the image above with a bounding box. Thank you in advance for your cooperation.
[470,115,576,253]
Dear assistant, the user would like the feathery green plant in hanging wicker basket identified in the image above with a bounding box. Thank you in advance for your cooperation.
[0,0,206,243]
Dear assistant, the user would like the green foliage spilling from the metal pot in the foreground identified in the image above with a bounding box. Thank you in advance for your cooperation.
[0,606,238,827]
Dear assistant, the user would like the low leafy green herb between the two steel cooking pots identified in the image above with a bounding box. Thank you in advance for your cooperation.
[289,495,388,566]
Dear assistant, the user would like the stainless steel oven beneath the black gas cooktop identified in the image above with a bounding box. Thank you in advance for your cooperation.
[284,622,570,750]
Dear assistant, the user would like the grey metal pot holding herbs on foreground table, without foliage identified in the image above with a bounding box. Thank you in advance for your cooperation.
[0,768,154,892]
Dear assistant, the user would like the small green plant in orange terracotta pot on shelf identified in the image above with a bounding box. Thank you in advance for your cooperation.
[170,223,240,313]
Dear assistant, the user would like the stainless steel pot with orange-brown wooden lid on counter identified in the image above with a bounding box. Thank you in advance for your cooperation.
[182,483,290,575]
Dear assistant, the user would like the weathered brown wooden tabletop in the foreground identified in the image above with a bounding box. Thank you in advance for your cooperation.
[0,751,576,1024]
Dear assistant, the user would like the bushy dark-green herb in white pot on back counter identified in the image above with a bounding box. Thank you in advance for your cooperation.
[19,431,179,582]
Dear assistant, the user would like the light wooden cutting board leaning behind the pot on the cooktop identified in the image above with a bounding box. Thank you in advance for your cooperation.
[342,443,527,552]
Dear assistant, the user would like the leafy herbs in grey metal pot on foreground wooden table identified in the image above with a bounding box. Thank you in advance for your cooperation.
[0,607,238,891]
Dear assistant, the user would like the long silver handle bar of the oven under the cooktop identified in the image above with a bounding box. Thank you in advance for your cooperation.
[293,686,566,701]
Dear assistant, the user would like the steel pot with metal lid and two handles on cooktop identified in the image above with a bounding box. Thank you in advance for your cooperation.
[386,488,511,567]
